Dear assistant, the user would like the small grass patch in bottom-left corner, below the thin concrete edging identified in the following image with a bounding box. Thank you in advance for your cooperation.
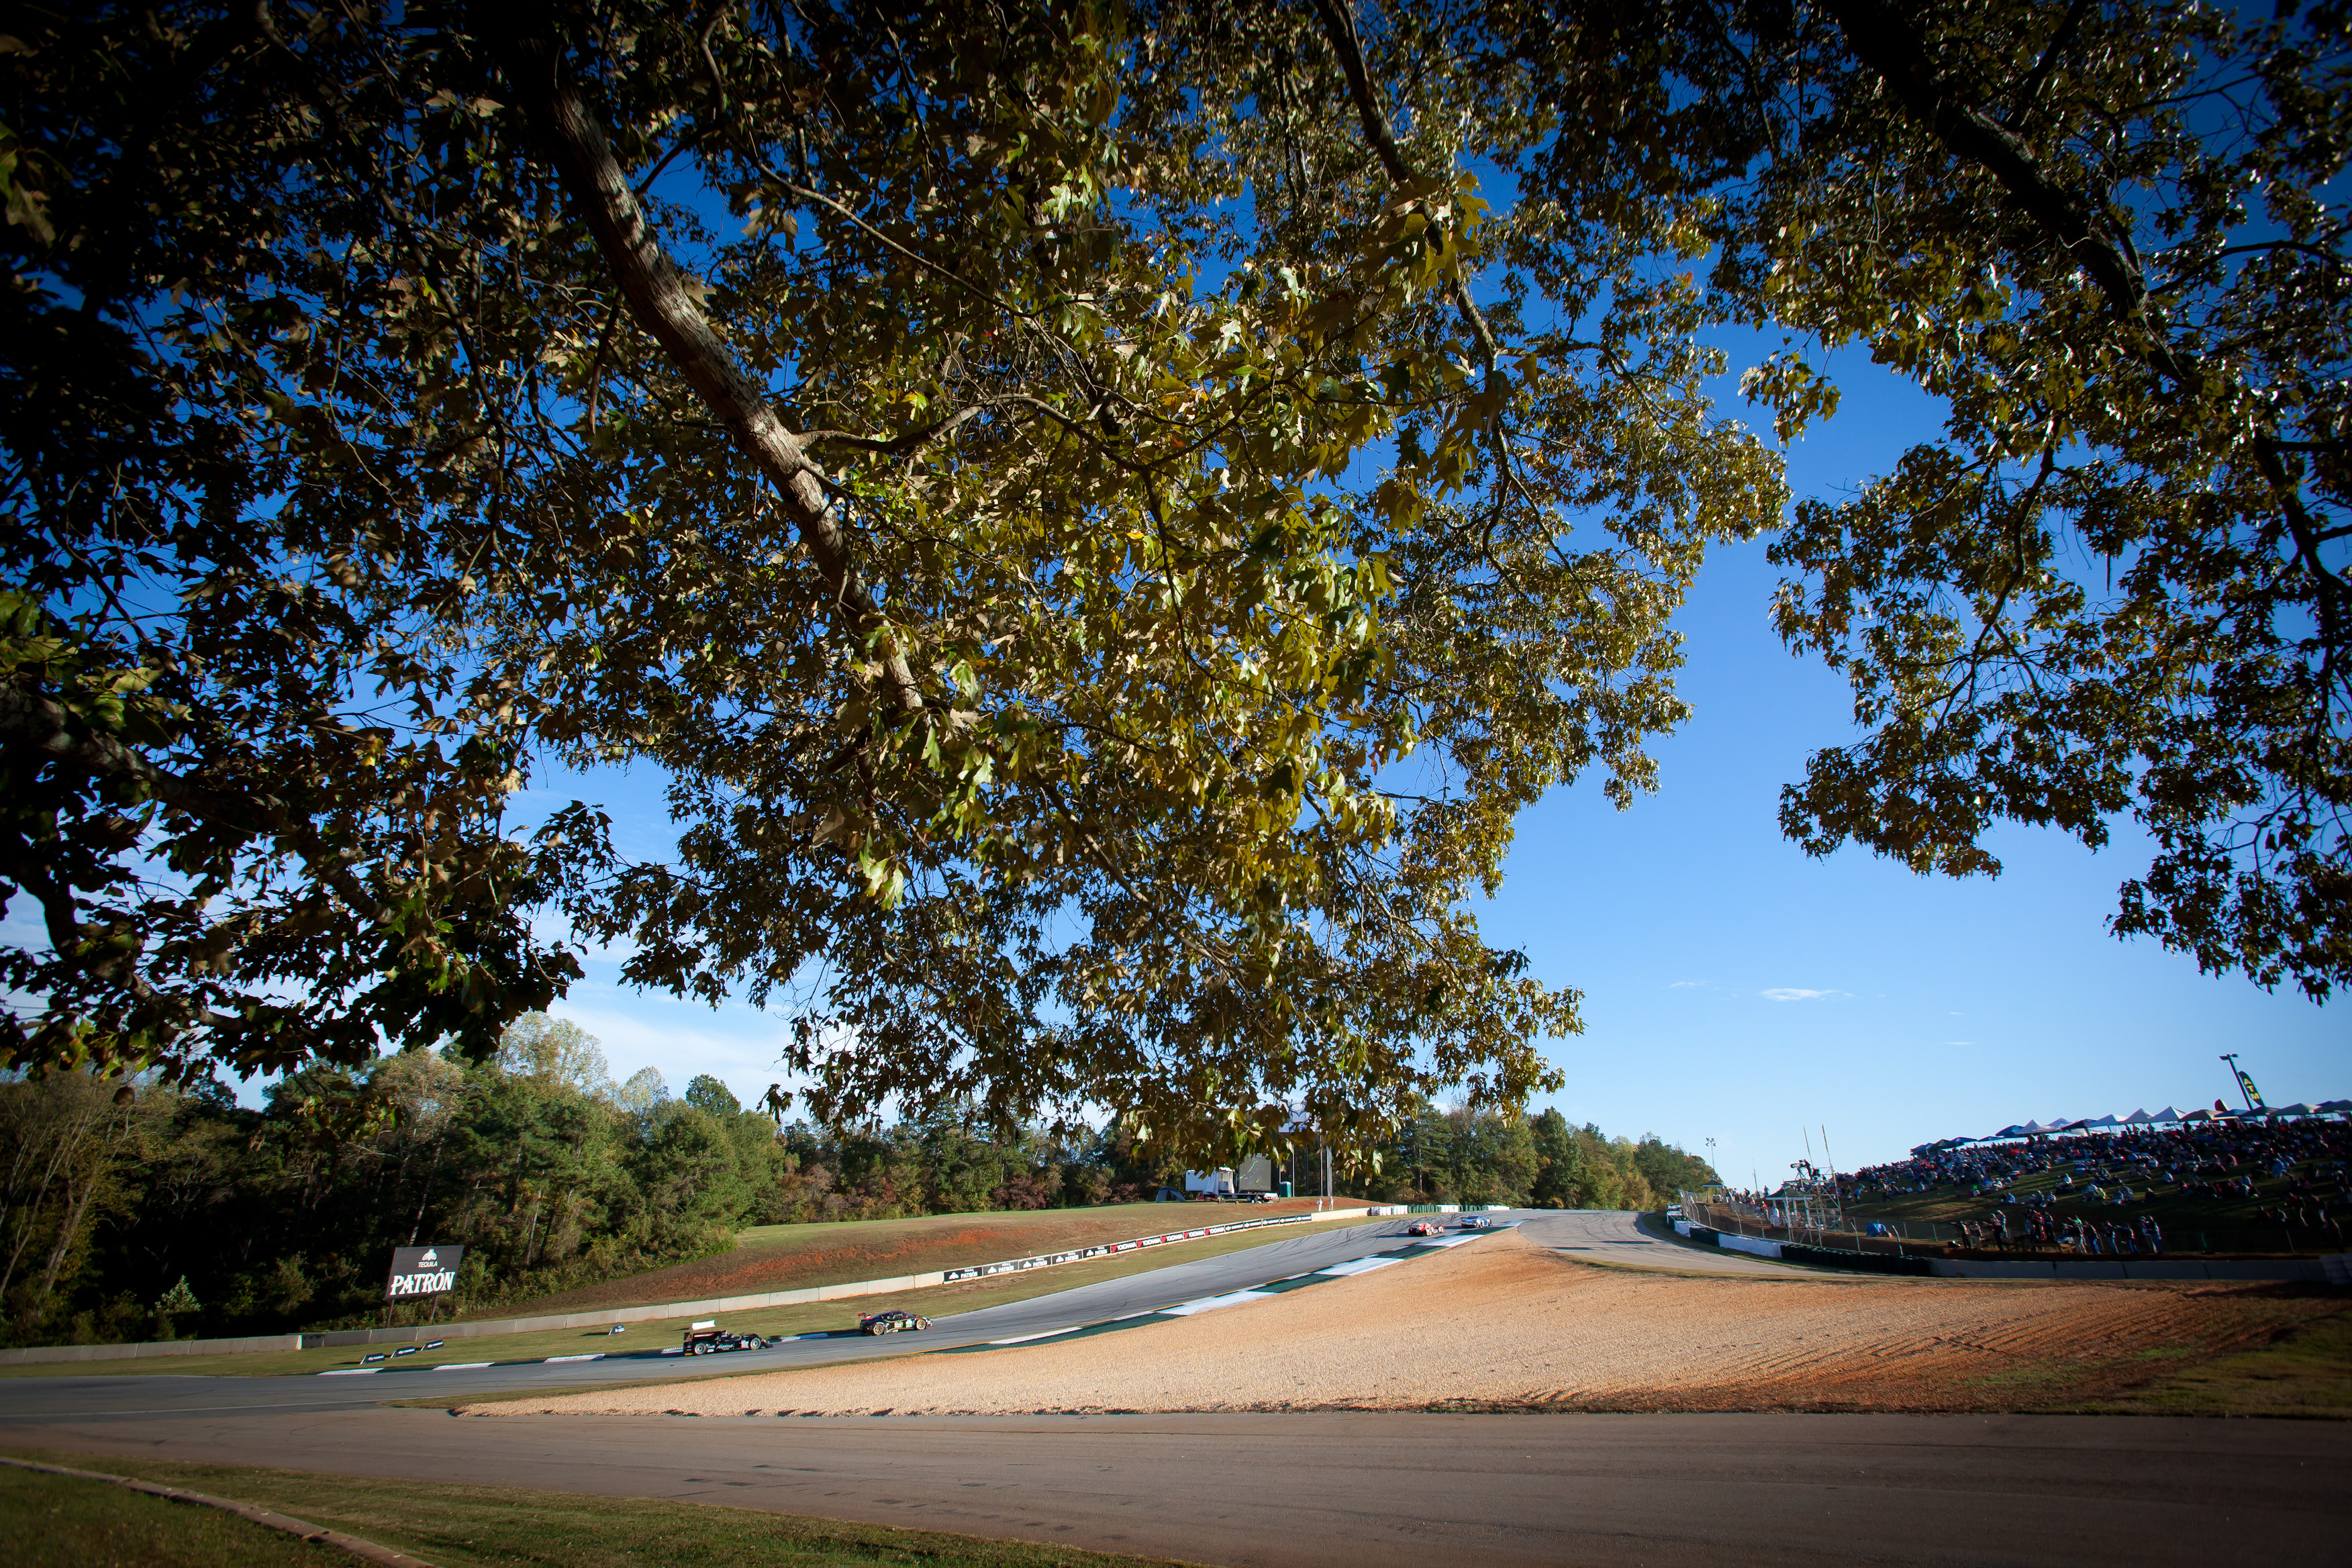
[0,1465,341,1568]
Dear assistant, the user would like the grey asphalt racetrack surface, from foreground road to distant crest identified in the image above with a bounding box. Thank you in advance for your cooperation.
[0,1216,2352,1568]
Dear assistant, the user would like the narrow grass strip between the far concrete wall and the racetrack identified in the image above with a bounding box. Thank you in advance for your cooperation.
[0,1206,1369,1385]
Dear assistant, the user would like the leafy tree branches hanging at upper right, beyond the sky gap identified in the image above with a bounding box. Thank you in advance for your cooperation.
[1655,0,2352,999]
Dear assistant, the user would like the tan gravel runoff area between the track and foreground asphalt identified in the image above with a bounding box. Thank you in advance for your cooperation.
[461,1232,2340,1415]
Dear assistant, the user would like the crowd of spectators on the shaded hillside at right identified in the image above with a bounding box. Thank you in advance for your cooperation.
[1837,1117,2352,1255]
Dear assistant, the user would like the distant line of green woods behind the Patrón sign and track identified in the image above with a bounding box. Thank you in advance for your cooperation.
[0,1013,1708,1344]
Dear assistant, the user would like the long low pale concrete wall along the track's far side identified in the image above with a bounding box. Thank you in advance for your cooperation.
[0,1206,1402,1366]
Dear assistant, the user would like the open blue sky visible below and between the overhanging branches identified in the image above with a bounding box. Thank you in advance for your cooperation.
[524,338,2352,1183]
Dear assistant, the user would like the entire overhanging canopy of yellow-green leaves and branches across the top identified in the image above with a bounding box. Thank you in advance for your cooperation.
[0,0,2352,1150]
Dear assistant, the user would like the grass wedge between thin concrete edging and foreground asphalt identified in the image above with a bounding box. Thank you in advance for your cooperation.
[0,1453,1204,1568]
